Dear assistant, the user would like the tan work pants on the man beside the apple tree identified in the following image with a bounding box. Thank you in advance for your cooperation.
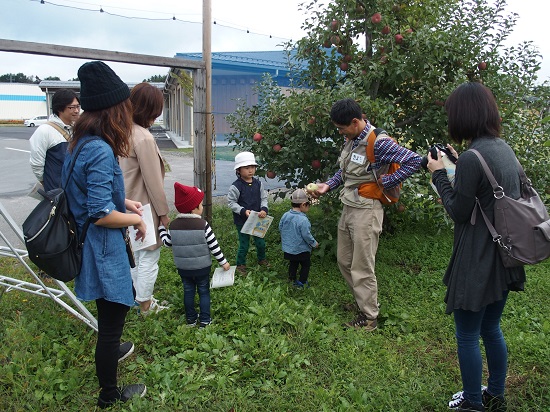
[337,200,384,319]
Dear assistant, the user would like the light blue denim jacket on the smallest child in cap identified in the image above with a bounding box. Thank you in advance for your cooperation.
[279,209,317,255]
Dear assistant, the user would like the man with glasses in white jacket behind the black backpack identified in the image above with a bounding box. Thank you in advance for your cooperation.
[30,89,80,191]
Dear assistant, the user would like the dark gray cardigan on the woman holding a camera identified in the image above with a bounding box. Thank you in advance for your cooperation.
[432,137,525,314]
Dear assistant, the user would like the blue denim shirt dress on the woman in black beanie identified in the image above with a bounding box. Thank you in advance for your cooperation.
[61,136,134,306]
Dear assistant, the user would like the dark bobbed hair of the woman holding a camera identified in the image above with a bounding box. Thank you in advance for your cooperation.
[445,82,500,143]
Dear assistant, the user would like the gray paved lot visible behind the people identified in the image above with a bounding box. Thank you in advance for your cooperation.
[0,127,284,247]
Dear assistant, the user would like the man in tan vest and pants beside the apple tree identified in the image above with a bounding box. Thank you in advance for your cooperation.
[308,99,421,331]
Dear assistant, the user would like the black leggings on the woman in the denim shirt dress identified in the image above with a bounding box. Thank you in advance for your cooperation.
[95,299,130,401]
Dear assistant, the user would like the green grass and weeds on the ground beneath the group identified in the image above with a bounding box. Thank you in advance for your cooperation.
[0,202,550,412]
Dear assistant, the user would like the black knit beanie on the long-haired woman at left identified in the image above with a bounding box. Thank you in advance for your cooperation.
[78,61,130,111]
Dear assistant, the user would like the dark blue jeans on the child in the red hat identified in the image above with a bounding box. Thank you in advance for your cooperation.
[180,272,212,323]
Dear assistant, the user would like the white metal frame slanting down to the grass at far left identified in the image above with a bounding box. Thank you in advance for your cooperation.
[0,202,97,332]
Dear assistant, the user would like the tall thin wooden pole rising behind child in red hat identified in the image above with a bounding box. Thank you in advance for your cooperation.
[202,0,213,224]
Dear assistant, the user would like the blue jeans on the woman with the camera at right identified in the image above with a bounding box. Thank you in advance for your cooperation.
[453,292,508,404]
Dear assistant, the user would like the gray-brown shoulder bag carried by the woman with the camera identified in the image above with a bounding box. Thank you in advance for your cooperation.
[470,149,550,268]
